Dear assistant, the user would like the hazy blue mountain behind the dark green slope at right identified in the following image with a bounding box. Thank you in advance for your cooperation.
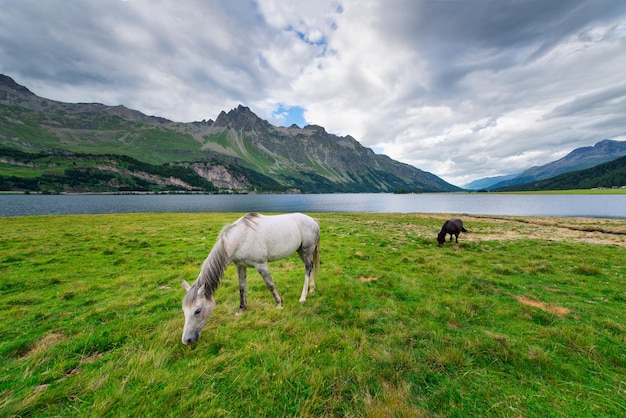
[466,139,626,190]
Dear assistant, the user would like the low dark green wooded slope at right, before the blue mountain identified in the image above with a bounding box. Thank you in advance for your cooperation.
[494,156,626,192]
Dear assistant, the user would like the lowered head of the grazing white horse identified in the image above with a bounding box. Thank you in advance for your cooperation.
[182,280,215,344]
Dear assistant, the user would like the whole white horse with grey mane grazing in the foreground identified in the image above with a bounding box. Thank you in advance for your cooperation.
[182,213,320,344]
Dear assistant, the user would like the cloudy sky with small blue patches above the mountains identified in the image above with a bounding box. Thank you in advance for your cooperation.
[0,0,626,185]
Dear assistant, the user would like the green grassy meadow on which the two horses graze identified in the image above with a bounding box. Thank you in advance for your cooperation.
[0,213,626,417]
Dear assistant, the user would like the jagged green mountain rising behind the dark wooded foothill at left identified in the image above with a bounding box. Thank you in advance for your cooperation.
[0,75,461,192]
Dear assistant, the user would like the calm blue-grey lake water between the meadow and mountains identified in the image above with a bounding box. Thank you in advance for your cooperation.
[0,193,626,218]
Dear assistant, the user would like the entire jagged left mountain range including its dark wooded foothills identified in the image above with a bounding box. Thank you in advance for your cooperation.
[0,75,461,192]
